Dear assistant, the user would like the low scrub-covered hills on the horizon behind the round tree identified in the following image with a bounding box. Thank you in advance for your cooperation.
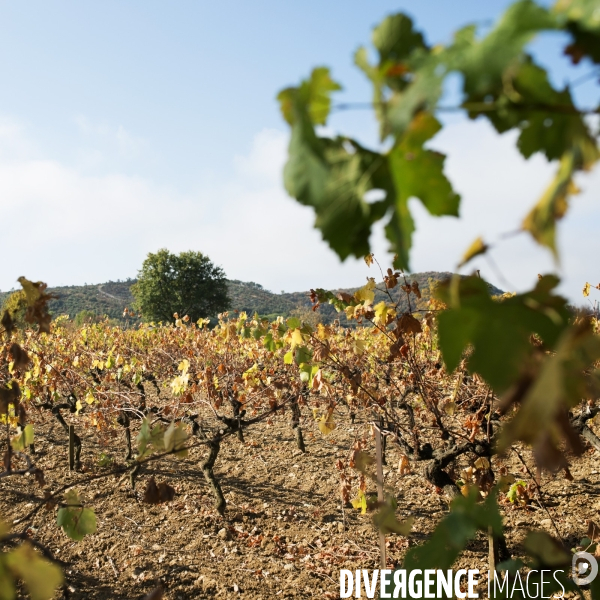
[0,271,502,325]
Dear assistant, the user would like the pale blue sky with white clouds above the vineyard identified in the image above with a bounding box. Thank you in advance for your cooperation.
[0,0,600,303]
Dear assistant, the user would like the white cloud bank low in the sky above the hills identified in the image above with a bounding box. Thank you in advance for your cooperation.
[0,118,600,300]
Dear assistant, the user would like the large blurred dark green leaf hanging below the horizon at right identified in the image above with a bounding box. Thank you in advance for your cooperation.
[436,275,569,393]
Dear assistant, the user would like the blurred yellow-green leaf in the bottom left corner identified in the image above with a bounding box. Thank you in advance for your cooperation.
[0,543,63,600]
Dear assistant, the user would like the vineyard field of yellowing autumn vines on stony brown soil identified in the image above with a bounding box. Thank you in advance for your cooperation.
[1,270,600,598]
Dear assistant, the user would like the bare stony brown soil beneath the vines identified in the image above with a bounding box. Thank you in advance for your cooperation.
[0,414,600,600]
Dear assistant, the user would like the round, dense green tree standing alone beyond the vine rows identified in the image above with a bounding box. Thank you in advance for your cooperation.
[131,248,230,322]
